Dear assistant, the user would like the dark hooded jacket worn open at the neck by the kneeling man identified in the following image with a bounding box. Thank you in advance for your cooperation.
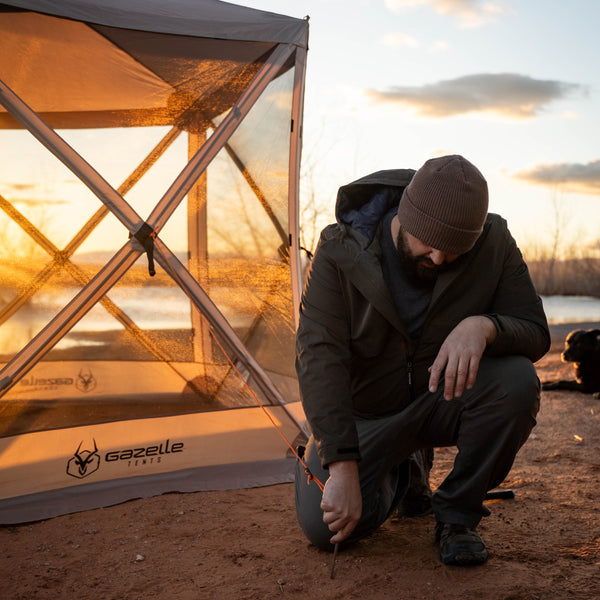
[296,170,550,465]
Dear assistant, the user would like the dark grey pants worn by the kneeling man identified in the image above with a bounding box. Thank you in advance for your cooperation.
[296,356,540,550]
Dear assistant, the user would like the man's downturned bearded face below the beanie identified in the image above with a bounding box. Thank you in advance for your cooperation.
[396,227,459,285]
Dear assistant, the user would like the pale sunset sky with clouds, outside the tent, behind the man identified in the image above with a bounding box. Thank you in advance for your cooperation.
[237,0,600,255]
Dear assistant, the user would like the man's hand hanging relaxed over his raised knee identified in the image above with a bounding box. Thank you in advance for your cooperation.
[429,316,497,400]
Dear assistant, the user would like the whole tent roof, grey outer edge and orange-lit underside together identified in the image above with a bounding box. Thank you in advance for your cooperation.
[0,0,308,128]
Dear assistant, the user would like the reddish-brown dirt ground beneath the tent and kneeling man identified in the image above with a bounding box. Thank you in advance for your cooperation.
[0,325,600,600]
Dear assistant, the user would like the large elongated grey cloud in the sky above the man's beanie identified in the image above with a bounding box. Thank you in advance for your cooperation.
[366,73,585,118]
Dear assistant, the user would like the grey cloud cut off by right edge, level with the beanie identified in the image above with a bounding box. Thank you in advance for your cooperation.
[514,160,600,196]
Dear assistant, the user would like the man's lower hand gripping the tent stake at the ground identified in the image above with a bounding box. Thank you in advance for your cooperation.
[321,460,362,544]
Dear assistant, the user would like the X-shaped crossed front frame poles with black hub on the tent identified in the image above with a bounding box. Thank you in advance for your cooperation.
[0,44,297,422]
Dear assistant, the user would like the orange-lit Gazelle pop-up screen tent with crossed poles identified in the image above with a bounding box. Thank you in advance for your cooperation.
[0,0,308,523]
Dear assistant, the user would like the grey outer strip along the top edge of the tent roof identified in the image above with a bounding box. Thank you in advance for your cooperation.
[1,0,308,48]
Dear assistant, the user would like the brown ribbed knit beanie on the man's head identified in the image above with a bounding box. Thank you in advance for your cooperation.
[398,154,488,254]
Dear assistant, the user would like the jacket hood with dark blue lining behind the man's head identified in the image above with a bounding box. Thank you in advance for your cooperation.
[335,169,416,240]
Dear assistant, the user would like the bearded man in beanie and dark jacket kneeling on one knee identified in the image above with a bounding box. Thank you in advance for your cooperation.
[296,155,550,565]
